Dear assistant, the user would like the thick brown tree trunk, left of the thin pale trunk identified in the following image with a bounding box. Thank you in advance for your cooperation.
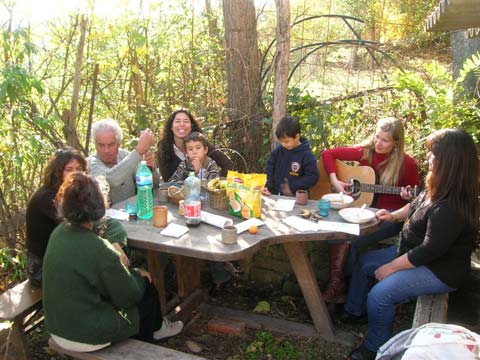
[223,0,265,171]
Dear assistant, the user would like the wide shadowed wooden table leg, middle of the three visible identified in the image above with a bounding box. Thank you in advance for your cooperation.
[175,255,200,300]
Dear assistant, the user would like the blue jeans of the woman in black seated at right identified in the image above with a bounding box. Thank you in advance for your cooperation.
[345,246,455,352]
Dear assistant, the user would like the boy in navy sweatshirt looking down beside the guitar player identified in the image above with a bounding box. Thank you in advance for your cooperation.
[262,116,320,196]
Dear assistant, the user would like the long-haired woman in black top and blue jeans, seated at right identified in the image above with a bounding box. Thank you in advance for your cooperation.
[344,129,480,360]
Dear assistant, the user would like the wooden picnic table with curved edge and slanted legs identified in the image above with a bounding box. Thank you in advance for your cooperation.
[113,195,378,339]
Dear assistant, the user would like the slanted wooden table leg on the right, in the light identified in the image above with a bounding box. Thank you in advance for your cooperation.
[283,242,334,340]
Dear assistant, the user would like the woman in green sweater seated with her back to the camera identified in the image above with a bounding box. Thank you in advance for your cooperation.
[43,172,183,351]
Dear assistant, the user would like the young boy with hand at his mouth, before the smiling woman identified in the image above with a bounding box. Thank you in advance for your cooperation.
[168,131,220,182]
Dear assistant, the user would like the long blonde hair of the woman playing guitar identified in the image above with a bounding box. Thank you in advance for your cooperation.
[361,117,405,185]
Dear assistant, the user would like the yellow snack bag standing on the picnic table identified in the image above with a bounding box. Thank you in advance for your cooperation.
[227,170,267,219]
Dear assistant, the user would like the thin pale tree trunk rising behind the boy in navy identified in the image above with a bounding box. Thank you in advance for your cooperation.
[271,0,290,148]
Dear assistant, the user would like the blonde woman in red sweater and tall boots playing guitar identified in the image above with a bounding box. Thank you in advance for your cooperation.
[322,117,420,302]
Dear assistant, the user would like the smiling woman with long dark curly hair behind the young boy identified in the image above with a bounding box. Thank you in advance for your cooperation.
[157,109,233,181]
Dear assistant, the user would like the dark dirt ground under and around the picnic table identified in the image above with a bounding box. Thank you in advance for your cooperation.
[23,262,480,360]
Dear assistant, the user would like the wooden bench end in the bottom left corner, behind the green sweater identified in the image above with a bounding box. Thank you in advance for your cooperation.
[0,280,43,360]
